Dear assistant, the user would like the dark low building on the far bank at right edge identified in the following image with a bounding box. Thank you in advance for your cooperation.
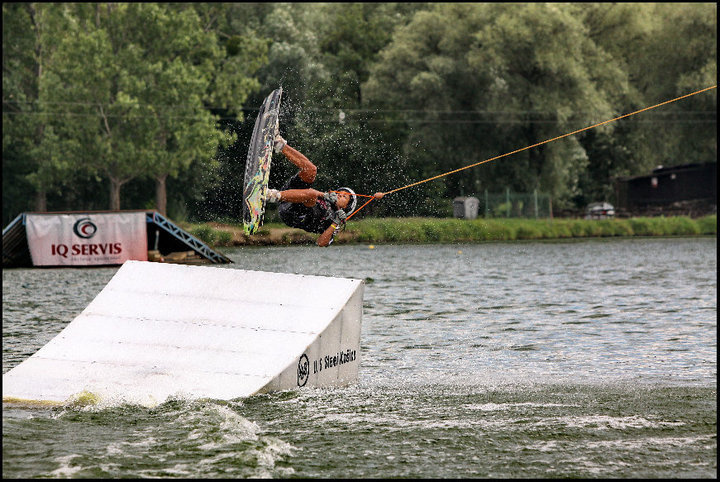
[615,162,717,215]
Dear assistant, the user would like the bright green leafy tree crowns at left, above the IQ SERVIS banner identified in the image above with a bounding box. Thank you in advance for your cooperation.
[3,4,263,217]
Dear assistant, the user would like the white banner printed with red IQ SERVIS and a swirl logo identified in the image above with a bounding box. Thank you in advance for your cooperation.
[25,212,148,266]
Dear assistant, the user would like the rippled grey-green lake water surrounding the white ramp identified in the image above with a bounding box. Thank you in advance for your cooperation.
[3,238,717,478]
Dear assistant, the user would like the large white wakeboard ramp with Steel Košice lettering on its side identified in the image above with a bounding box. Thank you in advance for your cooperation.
[2,261,364,404]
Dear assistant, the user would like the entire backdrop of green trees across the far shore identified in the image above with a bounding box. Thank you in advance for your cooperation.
[3,3,717,223]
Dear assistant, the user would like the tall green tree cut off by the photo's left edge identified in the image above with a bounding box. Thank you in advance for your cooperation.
[3,3,73,218]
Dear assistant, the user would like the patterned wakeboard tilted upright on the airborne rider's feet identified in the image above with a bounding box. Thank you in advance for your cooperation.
[243,87,282,235]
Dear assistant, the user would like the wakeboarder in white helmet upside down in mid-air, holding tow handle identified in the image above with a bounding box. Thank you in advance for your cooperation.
[267,134,384,247]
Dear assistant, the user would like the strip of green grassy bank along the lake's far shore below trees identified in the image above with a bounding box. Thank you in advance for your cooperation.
[183,215,717,247]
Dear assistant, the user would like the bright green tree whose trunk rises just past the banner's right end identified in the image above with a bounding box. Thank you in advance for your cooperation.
[124,4,248,214]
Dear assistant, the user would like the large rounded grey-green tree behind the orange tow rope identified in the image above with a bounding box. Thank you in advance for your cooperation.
[366,4,627,209]
